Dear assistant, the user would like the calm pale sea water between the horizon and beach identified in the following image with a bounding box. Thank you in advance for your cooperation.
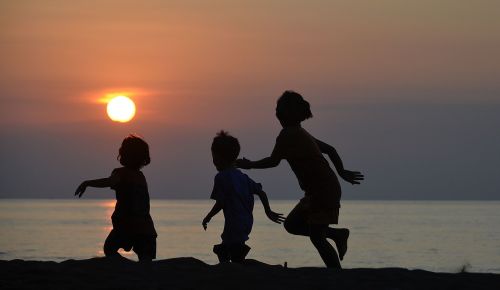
[0,199,500,273]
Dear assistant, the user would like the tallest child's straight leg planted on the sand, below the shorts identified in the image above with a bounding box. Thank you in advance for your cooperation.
[309,224,342,269]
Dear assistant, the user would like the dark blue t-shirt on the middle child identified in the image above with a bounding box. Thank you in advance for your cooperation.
[210,168,262,244]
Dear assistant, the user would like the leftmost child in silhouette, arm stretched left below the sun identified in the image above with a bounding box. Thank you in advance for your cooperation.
[75,135,158,262]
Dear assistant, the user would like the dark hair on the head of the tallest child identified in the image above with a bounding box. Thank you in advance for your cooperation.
[276,91,312,122]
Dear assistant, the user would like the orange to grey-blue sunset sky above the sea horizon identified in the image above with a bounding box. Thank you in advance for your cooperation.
[0,0,500,200]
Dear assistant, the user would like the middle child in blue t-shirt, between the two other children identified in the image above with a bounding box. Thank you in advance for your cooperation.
[202,131,284,263]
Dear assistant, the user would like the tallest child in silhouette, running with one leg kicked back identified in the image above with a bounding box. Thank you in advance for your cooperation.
[236,91,364,269]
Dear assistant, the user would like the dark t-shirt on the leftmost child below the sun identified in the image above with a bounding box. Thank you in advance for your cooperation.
[111,167,157,237]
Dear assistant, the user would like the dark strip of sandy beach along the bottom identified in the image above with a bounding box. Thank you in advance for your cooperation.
[0,258,500,290]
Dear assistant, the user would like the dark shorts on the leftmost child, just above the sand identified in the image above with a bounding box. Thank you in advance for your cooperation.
[104,229,156,259]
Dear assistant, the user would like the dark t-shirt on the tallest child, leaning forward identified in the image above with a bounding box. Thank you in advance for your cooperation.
[272,127,341,207]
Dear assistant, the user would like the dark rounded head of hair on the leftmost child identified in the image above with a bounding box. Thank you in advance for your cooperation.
[116,134,151,169]
